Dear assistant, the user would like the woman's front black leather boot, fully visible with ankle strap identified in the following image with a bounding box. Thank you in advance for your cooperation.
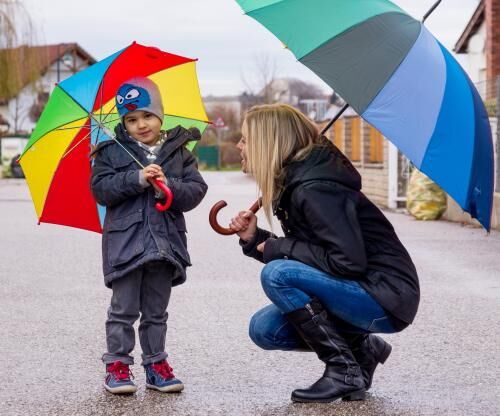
[285,301,365,403]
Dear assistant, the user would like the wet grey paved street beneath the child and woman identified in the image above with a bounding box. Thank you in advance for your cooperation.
[0,173,500,416]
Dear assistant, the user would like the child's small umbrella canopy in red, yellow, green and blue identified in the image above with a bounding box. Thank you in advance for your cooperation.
[20,42,208,232]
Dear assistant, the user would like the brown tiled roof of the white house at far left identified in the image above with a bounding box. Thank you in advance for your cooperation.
[0,43,97,102]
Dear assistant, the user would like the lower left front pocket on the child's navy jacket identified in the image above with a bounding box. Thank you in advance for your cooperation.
[107,212,144,267]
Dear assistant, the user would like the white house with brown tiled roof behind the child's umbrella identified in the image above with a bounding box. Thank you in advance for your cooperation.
[0,43,96,135]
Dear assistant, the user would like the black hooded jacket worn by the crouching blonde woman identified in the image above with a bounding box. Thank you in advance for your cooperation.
[240,145,420,330]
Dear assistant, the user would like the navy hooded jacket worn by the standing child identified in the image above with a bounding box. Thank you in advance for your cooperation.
[91,124,207,287]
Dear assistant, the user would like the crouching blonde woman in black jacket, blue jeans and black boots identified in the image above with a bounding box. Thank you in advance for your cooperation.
[230,104,419,402]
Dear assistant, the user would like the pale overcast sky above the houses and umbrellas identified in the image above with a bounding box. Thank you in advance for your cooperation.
[24,0,479,95]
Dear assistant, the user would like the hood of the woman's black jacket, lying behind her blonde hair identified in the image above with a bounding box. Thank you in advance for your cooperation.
[283,143,361,191]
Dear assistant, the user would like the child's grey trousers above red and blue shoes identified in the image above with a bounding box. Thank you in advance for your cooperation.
[102,262,175,365]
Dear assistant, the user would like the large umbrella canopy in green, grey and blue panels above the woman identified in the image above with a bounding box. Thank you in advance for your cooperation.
[237,0,494,230]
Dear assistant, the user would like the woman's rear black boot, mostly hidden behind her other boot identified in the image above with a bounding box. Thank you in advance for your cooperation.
[343,334,392,391]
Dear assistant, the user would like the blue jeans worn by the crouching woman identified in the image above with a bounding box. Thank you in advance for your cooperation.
[249,260,396,351]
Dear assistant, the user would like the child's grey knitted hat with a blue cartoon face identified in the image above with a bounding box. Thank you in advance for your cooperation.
[116,77,164,122]
